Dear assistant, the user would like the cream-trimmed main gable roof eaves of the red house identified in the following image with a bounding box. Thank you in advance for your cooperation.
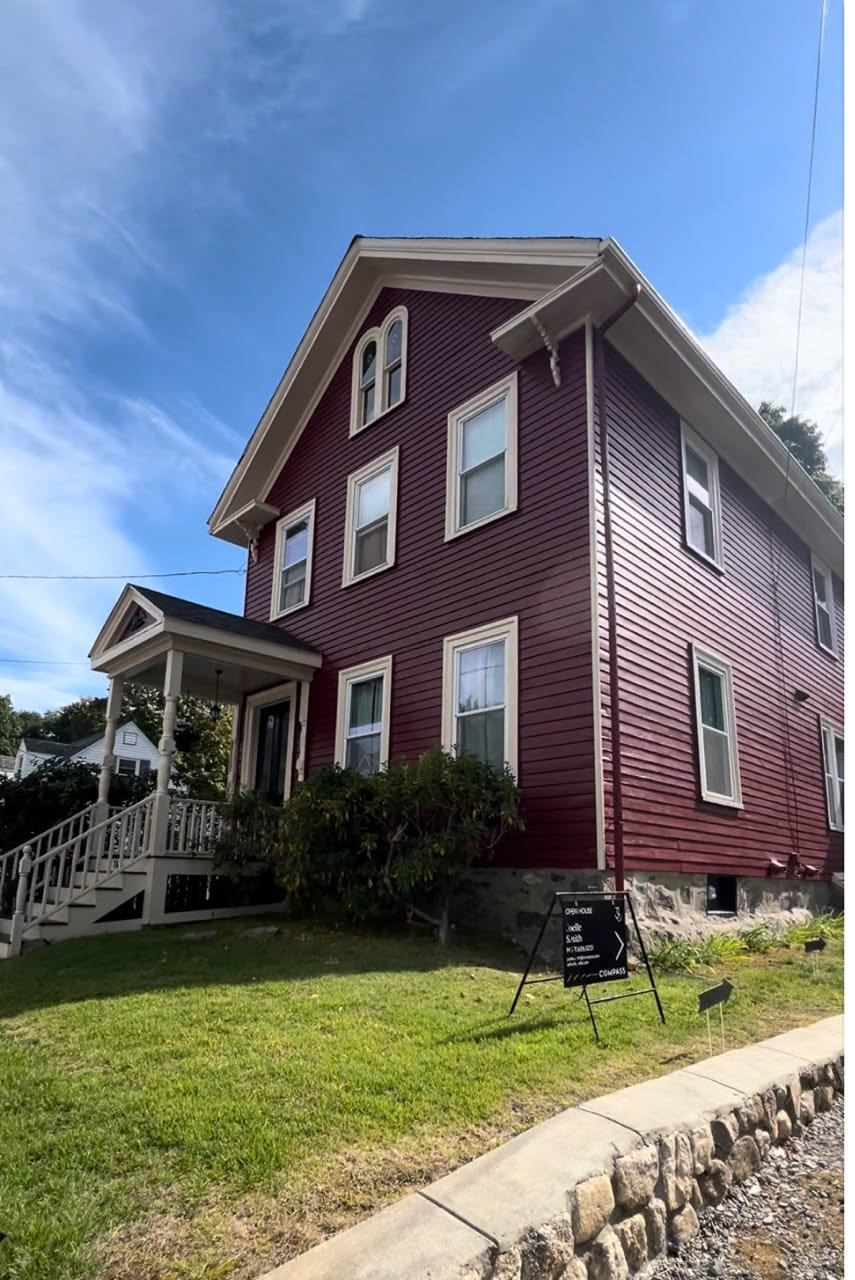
[209,236,843,576]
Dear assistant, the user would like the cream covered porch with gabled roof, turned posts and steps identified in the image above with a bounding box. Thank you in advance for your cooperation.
[0,585,321,955]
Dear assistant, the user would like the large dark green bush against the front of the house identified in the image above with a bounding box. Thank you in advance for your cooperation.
[218,750,522,941]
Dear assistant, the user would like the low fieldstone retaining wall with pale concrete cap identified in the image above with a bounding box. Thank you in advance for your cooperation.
[261,1016,843,1280]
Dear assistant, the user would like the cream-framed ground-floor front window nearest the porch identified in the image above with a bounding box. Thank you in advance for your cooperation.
[335,657,392,774]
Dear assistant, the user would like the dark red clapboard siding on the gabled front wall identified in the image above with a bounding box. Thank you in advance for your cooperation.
[246,289,596,867]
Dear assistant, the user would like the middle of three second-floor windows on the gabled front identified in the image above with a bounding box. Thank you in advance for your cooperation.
[342,448,398,586]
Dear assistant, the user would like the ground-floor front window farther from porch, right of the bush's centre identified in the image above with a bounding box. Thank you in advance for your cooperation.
[443,618,518,773]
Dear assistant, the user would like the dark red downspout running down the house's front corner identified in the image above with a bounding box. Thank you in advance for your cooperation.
[594,282,641,890]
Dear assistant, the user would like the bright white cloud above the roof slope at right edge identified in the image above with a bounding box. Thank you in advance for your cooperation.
[700,214,843,474]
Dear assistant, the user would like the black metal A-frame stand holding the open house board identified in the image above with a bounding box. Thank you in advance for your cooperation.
[508,890,666,1041]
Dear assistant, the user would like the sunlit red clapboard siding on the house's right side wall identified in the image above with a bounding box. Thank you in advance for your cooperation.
[599,348,843,876]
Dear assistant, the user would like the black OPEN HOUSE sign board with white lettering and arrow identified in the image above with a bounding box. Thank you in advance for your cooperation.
[561,893,628,987]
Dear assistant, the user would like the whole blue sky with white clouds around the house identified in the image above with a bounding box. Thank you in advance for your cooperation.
[0,0,842,709]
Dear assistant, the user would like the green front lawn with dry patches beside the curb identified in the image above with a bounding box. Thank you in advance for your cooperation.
[0,922,842,1280]
